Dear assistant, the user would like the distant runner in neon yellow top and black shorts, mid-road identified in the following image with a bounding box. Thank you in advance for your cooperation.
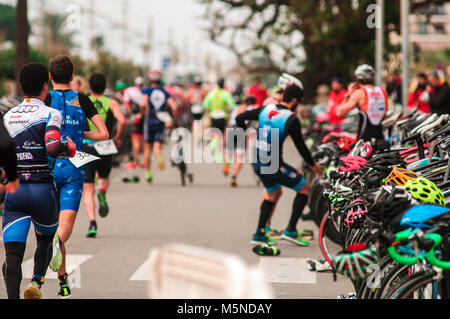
[203,79,236,177]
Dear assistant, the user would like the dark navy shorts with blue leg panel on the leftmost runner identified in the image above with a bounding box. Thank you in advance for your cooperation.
[3,183,59,243]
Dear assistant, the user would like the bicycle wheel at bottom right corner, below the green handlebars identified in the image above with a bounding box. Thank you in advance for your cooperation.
[386,269,440,299]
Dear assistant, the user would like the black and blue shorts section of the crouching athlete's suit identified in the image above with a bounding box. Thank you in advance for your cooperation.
[253,163,306,193]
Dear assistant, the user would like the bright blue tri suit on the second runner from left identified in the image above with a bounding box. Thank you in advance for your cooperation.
[45,90,98,212]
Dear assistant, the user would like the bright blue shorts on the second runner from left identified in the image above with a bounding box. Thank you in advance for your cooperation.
[52,159,84,212]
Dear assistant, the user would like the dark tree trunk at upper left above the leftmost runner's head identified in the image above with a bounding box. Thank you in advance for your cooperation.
[16,0,29,95]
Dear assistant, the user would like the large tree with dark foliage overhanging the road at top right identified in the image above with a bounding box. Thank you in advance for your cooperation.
[200,0,450,100]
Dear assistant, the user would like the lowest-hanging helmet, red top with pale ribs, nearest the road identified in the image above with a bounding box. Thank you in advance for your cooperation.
[333,243,379,280]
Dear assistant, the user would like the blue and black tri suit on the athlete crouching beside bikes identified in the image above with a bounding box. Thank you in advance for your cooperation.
[236,104,314,193]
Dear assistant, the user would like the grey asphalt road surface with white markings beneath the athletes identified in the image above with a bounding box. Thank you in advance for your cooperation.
[0,142,352,299]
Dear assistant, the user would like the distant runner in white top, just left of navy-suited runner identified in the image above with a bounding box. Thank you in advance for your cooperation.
[123,76,144,169]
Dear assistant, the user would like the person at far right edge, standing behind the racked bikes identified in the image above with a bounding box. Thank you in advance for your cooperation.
[426,71,450,114]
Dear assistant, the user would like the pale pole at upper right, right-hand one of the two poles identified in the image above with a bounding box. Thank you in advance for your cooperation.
[400,0,410,108]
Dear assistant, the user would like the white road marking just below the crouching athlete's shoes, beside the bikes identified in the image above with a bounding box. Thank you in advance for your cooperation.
[258,257,317,284]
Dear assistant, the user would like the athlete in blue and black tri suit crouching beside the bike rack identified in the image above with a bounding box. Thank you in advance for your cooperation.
[236,84,322,250]
